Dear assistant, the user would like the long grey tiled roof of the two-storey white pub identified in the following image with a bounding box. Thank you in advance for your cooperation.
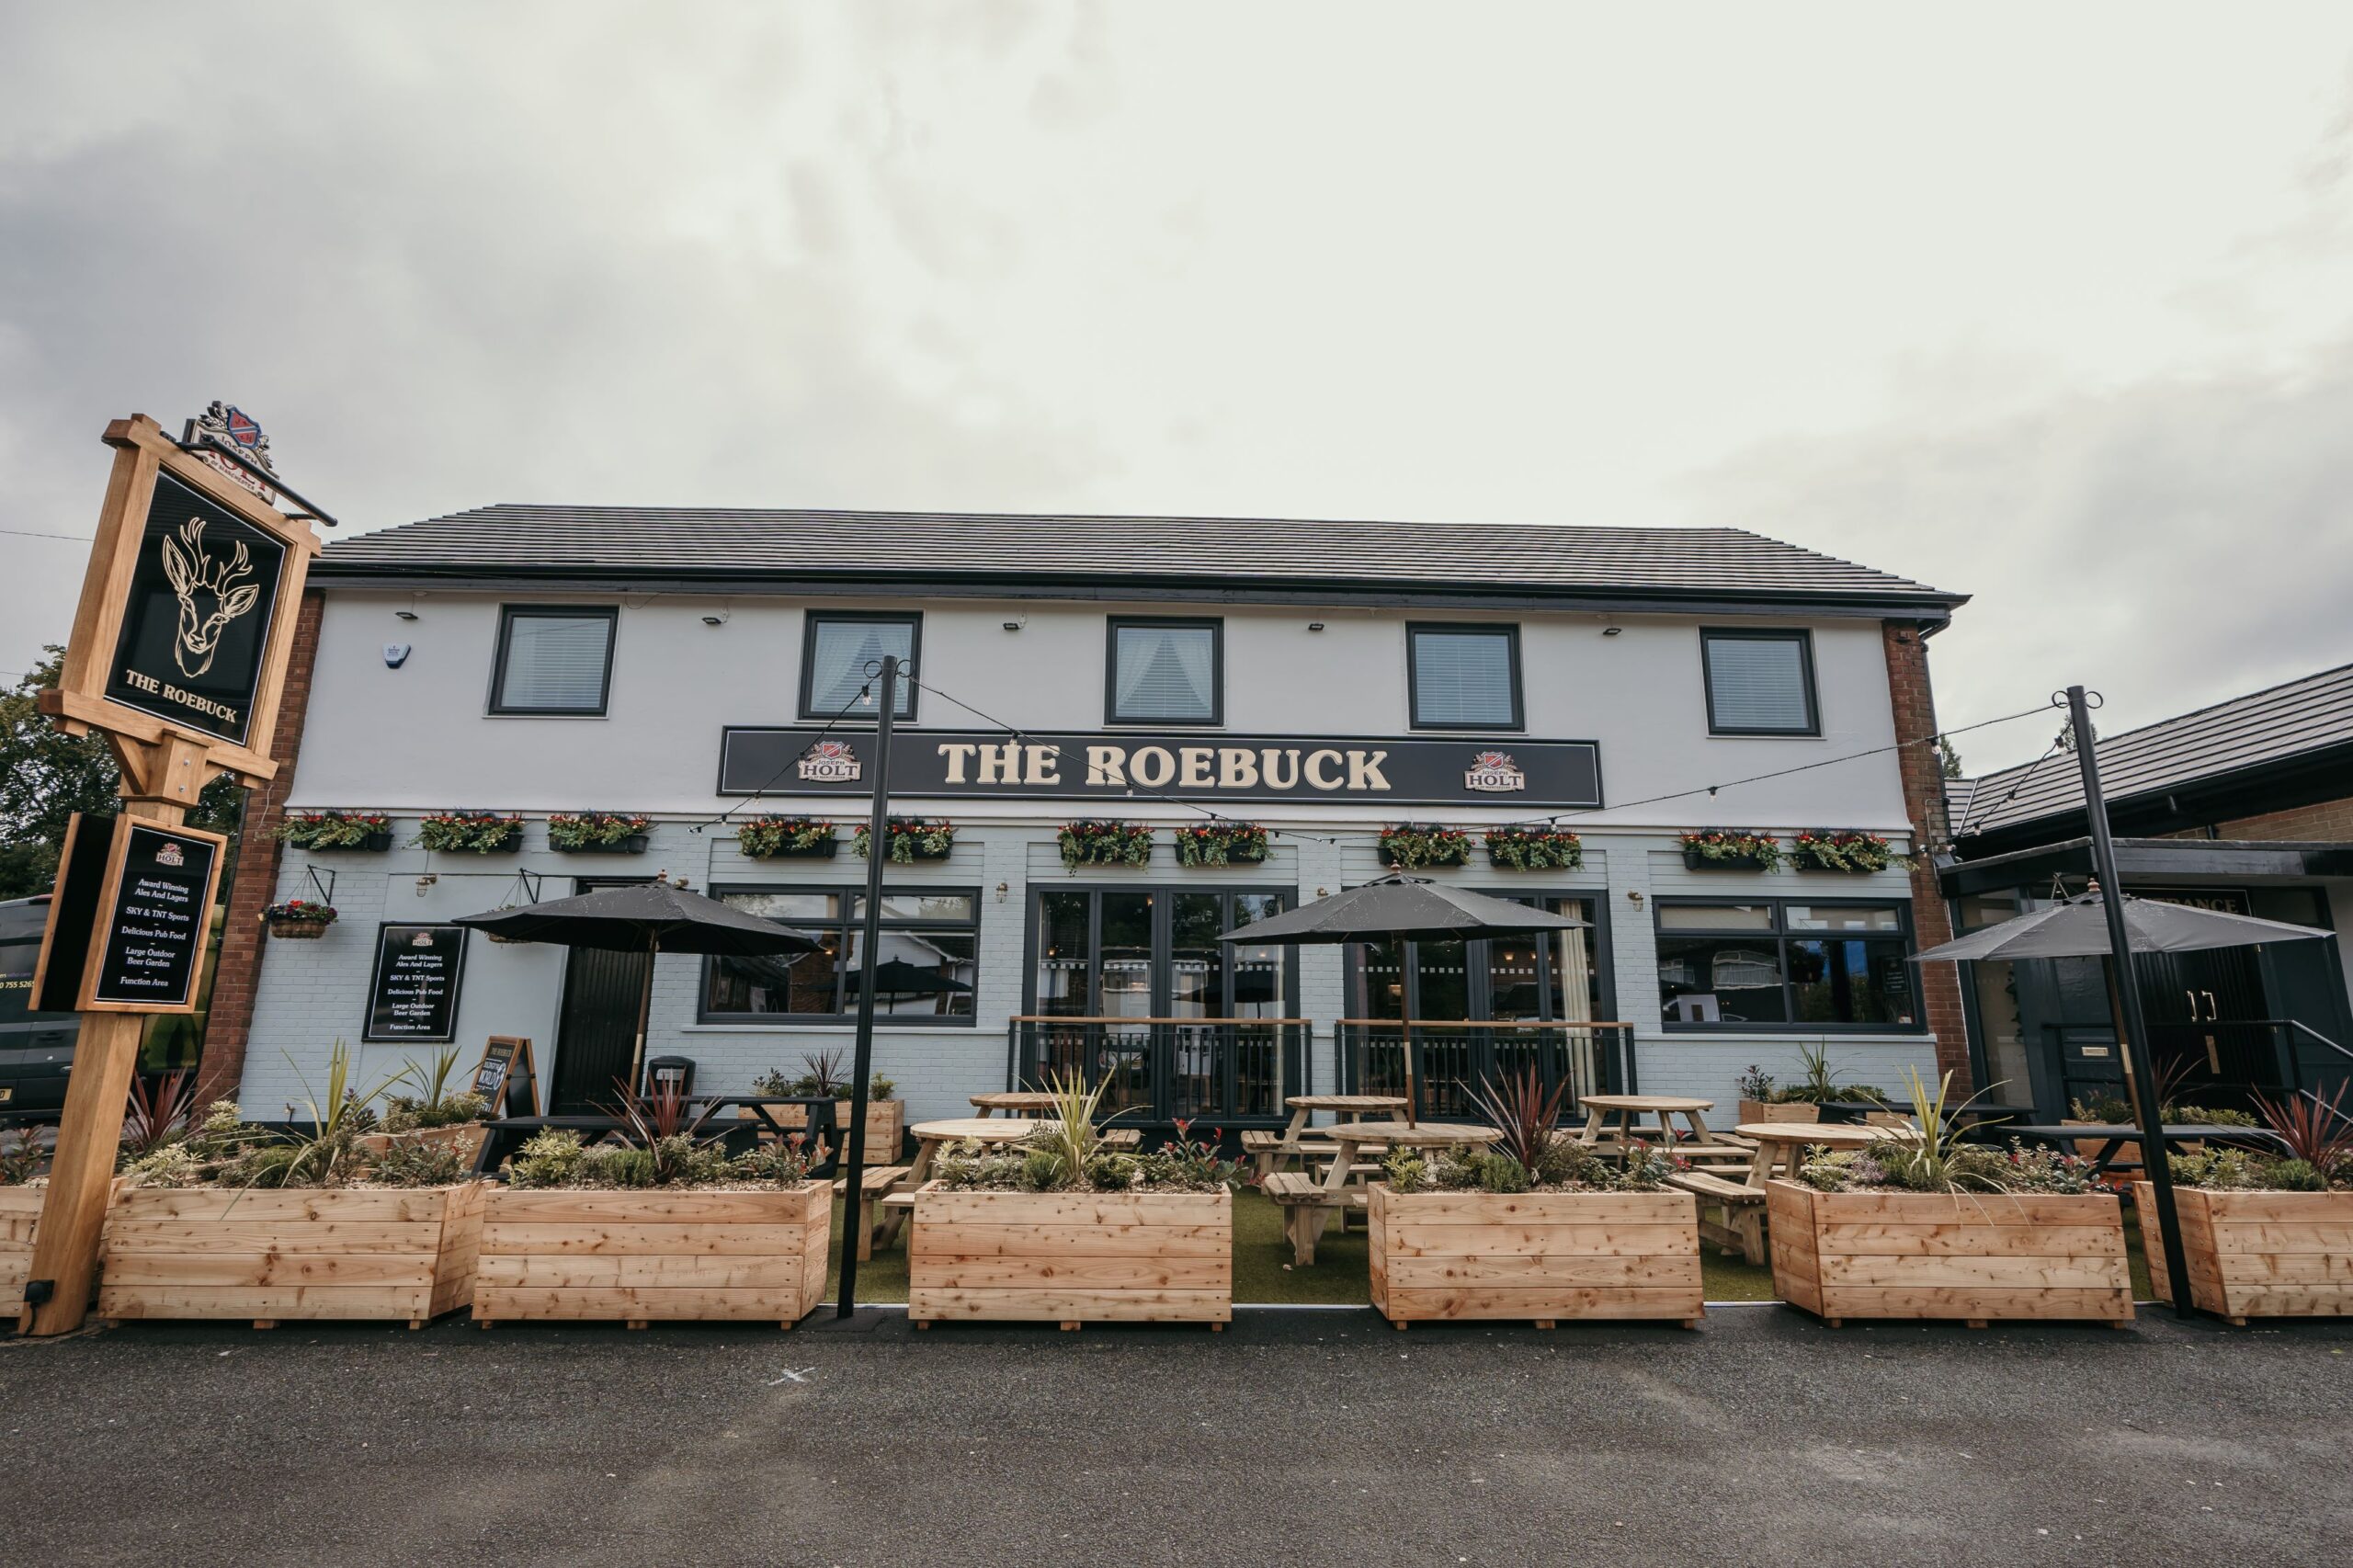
[313,506,1967,617]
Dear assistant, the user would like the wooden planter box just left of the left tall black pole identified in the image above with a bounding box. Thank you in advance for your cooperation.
[473,1182,833,1328]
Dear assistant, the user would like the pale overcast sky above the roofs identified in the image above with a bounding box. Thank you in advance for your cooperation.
[0,0,2353,766]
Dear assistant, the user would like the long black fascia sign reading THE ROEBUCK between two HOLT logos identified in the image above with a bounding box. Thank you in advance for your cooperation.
[720,728,1602,808]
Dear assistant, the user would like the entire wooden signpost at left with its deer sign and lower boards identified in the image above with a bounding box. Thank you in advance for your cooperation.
[18,405,318,1335]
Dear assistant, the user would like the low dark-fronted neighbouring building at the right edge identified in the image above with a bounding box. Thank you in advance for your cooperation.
[1941,664,2353,1120]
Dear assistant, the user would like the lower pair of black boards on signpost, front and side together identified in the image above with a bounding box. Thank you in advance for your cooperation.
[33,812,228,1012]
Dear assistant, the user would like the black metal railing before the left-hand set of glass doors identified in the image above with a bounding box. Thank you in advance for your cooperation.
[1005,1015,1315,1128]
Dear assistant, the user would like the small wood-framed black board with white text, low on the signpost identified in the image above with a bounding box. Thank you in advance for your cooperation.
[85,819,222,1012]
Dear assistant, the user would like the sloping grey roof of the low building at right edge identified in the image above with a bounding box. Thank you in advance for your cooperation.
[1949,664,2353,835]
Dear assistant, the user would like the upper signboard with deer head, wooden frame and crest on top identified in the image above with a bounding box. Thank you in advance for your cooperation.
[42,410,318,801]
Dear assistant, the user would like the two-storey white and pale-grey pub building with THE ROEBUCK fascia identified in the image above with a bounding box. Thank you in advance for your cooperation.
[205,506,1967,1132]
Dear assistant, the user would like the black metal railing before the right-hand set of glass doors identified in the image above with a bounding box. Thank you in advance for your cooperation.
[1339,1017,1640,1120]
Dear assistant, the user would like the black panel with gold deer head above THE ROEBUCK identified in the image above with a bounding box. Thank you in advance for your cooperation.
[106,473,290,746]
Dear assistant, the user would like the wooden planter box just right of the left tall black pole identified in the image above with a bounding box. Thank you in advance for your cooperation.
[906,1182,1233,1328]
